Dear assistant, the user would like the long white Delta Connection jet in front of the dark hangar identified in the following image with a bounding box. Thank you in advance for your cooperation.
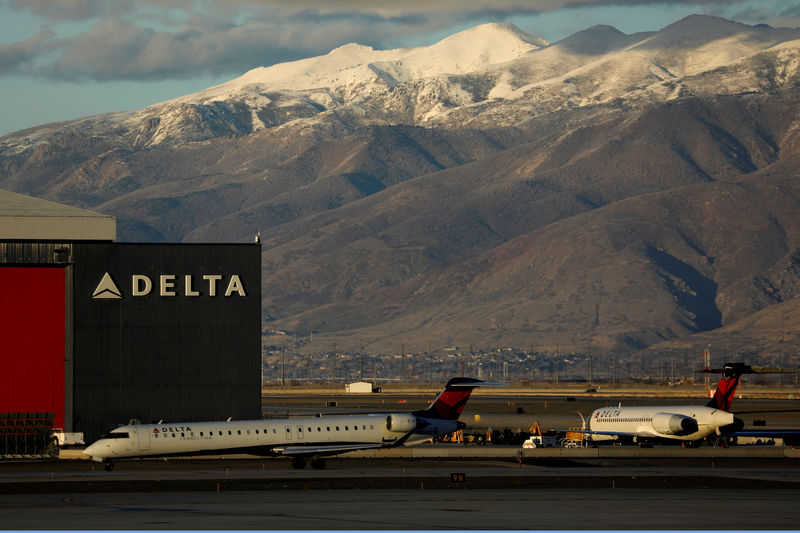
[84,377,498,470]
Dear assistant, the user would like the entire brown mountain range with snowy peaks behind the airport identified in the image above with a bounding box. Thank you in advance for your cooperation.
[0,16,800,361]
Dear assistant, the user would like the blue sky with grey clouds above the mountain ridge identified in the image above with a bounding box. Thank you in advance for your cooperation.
[0,0,800,135]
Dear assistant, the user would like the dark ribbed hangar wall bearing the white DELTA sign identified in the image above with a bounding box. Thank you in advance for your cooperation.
[73,243,261,442]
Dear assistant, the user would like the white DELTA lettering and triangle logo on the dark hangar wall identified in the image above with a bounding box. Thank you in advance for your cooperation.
[92,272,247,300]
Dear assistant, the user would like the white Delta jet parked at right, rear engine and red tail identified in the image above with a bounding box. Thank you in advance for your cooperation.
[576,363,796,445]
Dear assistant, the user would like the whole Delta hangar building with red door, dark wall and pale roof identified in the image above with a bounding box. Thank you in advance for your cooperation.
[0,190,261,443]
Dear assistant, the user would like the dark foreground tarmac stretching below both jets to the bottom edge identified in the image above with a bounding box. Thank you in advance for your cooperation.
[0,446,800,530]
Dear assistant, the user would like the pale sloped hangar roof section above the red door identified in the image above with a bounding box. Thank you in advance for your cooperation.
[0,190,117,241]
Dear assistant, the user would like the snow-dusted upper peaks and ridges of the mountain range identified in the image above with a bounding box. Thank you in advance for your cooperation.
[111,16,800,144]
